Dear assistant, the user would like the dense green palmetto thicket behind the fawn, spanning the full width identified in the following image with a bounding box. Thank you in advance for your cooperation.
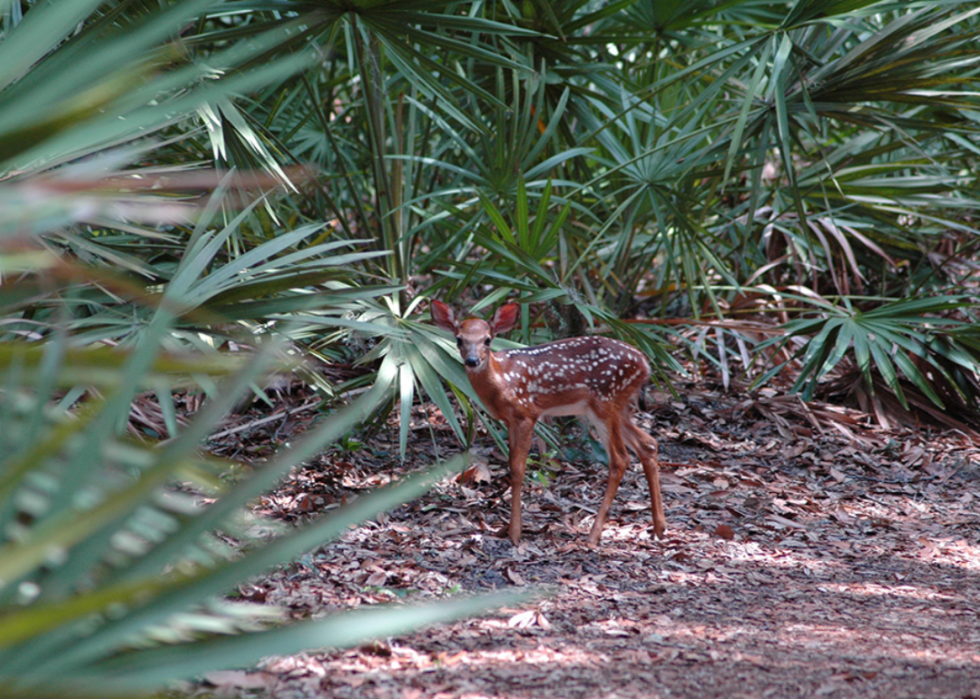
[0,0,980,688]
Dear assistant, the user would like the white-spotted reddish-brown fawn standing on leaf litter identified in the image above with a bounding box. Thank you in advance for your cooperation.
[431,301,667,546]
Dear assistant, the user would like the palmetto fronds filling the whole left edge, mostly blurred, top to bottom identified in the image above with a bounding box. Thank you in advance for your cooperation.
[0,0,520,696]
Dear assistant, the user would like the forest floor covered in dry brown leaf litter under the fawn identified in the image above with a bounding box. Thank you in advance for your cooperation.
[201,383,980,699]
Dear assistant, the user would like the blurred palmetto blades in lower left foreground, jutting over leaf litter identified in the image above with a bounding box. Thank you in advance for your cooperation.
[0,318,498,696]
